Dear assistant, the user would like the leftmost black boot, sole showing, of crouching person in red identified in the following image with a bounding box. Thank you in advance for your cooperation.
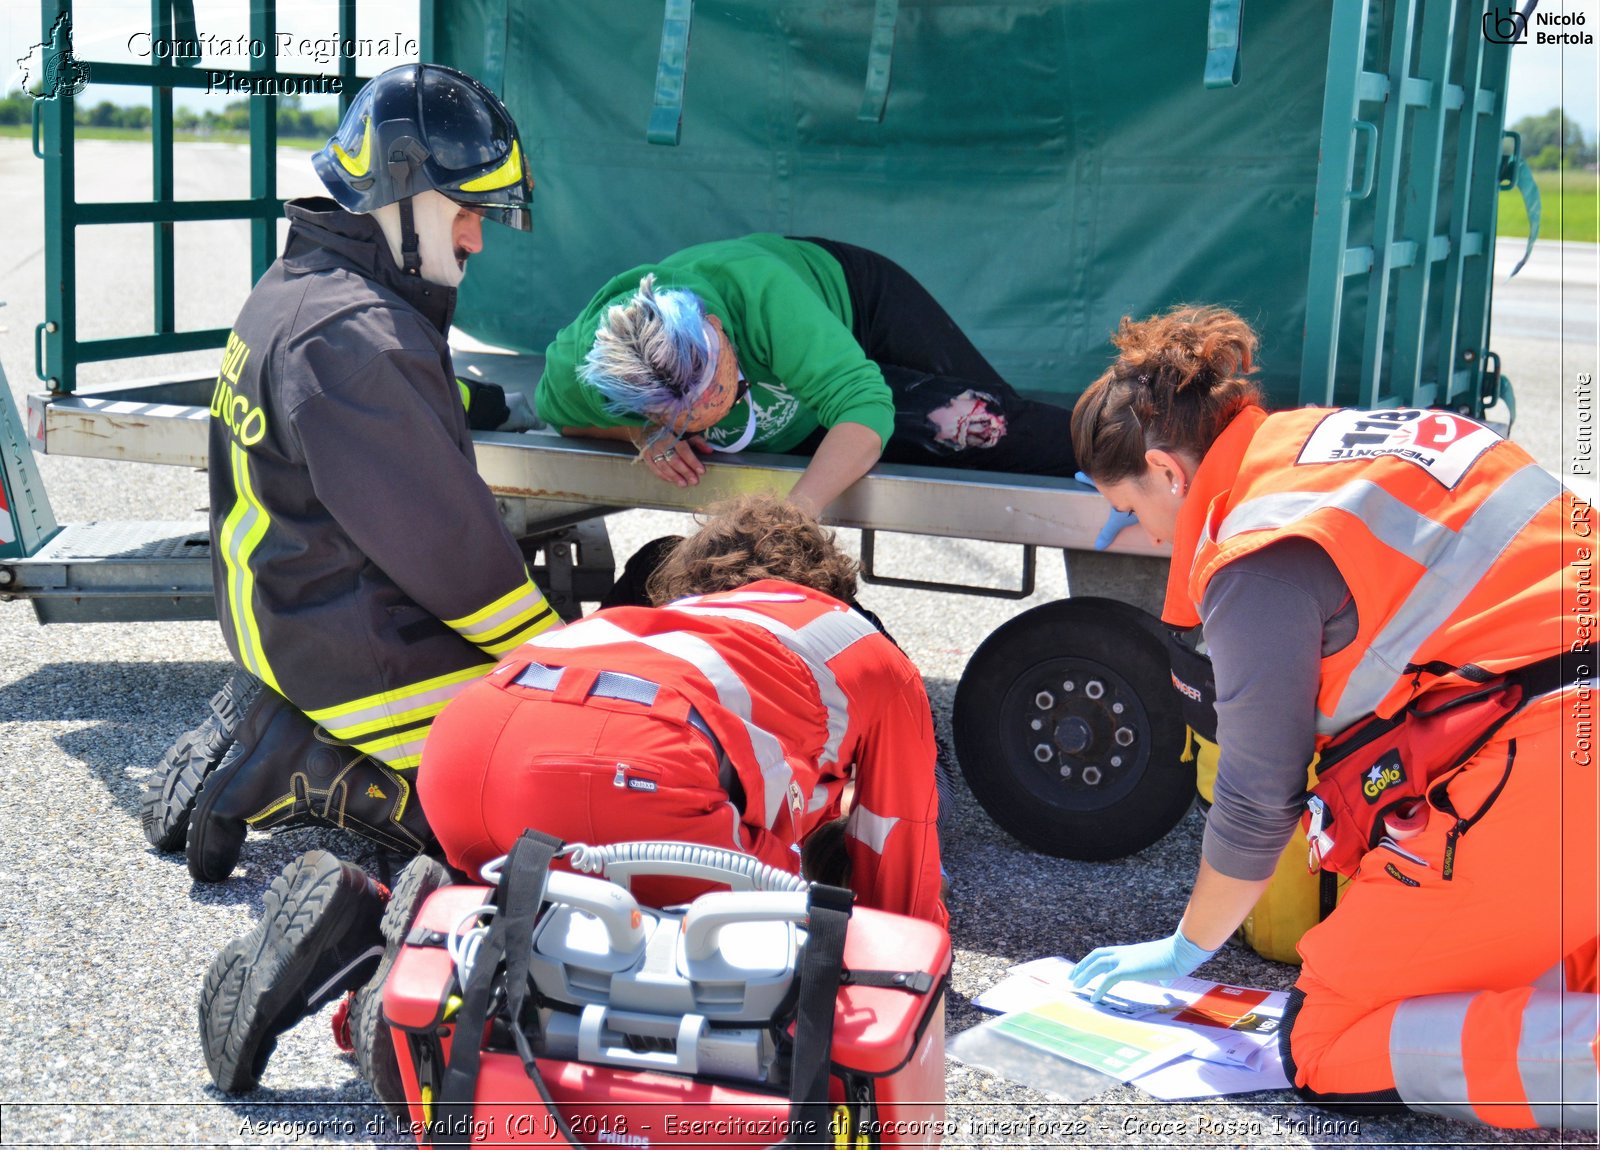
[200,851,386,1094]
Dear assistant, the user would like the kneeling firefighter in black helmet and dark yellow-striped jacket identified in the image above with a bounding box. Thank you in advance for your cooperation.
[142,64,560,881]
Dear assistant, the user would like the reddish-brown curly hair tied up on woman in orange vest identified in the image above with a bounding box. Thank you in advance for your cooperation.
[1072,304,1262,483]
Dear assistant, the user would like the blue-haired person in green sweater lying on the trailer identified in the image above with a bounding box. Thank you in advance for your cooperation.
[538,235,1077,515]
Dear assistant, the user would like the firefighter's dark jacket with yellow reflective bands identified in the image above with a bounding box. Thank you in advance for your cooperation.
[210,198,558,768]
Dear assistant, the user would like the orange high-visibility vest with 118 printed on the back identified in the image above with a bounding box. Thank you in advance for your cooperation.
[1163,408,1595,745]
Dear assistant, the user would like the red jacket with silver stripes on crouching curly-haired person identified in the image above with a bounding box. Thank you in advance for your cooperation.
[508,581,946,923]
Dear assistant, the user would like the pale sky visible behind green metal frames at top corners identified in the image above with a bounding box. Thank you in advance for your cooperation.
[0,0,1600,139]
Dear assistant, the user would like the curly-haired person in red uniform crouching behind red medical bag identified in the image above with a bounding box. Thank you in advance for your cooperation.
[200,497,949,1102]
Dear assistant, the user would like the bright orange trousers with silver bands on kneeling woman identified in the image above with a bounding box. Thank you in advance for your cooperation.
[1286,685,1600,1129]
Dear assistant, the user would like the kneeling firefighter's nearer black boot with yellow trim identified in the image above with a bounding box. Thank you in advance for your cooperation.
[189,696,434,883]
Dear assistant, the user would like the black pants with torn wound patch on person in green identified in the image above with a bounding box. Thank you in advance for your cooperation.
[797,237,1077,475]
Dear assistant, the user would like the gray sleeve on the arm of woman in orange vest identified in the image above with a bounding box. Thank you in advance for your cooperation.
[1200,539,1357,880]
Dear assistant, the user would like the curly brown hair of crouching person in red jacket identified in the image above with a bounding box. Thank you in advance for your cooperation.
[645,496,861,605]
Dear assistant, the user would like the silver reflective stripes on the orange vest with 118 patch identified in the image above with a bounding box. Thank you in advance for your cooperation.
[1216,464,1562,736]
